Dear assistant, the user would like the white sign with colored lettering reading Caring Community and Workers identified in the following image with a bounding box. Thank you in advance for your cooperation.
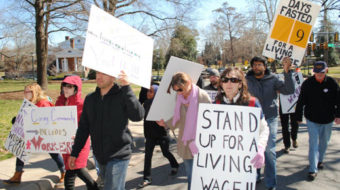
[24,106,78,154]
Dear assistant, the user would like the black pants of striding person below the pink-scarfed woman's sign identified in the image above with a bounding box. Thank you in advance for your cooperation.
[144,137,179,180]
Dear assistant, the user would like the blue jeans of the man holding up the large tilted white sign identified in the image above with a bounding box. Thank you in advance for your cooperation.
[98,159,130,190]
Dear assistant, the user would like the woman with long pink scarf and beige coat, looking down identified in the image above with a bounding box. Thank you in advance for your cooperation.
[158,72,211,189]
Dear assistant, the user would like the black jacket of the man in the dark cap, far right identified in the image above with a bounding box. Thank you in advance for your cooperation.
[295,76,340,124]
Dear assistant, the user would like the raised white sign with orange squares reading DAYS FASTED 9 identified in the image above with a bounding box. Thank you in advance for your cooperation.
[263,0,321,66]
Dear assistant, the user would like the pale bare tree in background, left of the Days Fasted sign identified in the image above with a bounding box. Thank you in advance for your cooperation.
[214,2,246,65]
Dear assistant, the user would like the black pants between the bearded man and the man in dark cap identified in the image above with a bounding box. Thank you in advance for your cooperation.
[280,109,299,148]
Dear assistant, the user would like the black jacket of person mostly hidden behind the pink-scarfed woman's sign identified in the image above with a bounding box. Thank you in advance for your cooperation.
[143,99,169,139]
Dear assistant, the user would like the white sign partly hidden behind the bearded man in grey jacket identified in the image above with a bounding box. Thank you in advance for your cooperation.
[280,72,304,114]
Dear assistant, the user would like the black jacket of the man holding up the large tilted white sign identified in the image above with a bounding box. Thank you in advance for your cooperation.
[71,84,144,164]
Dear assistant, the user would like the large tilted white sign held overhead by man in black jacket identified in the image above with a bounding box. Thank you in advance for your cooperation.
[82,5,153,88]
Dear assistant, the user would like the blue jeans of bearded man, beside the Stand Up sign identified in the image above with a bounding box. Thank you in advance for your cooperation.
[257,117,278,188]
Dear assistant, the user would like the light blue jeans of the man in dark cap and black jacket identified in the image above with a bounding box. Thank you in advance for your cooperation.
[307,119,333,173]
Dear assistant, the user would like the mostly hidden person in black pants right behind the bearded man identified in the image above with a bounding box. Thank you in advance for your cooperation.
[279,66,302,154]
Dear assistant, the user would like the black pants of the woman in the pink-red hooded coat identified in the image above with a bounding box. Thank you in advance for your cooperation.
[64,168,98,190]
